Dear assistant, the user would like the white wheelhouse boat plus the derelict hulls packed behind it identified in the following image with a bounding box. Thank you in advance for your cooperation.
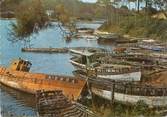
[70,39,167,81]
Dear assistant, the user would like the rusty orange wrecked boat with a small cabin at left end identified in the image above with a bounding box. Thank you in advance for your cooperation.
[0,59,86,100]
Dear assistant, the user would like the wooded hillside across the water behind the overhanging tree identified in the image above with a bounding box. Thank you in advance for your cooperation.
[0,0,105,20]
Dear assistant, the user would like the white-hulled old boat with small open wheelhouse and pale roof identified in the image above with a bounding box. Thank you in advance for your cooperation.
[70,51,141,81]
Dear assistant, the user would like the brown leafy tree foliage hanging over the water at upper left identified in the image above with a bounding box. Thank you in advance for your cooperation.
[9,0,49,42]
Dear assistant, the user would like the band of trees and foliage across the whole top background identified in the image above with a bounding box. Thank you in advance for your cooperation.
[0,0,167,42]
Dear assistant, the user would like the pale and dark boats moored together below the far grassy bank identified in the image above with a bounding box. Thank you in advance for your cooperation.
[75,28,138,44]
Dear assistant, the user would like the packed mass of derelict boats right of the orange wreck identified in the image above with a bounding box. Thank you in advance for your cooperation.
[70,40,167,106]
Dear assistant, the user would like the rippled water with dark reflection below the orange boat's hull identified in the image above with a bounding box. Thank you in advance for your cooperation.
[0,84,36,116]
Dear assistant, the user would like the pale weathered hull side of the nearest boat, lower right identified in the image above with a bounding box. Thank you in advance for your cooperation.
[91,87,167,107]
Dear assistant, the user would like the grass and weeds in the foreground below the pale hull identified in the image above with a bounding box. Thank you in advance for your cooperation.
[83,96,163,117]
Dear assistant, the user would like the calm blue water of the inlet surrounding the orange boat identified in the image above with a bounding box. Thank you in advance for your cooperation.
[0,20,111,116]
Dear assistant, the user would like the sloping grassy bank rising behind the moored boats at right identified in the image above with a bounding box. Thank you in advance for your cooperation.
[99,14,167,41]
